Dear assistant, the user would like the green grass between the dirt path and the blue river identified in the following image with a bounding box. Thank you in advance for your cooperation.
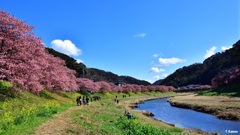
[66,92,183,135]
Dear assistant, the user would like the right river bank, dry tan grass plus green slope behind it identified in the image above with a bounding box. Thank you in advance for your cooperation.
[170,84,240,120]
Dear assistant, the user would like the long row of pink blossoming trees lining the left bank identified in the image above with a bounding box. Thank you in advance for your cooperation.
[0,10,174,93]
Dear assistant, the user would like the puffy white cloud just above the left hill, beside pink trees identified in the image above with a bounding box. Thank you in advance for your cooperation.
[51,39,82,56]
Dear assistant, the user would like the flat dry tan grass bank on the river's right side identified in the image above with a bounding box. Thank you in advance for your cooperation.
[169,94,240,121]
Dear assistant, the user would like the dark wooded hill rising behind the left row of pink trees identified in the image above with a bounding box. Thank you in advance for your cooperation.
[46,48,151,85]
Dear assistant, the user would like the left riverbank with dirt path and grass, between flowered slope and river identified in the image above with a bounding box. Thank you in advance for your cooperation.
[35,92,183,135]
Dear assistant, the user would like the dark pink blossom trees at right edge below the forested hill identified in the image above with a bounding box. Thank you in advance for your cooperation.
[212,68,240,87]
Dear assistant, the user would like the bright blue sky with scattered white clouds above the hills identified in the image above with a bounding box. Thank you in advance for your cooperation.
[0,0,240,82]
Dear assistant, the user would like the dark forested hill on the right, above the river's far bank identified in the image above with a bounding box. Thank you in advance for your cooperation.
[155,40,240,87]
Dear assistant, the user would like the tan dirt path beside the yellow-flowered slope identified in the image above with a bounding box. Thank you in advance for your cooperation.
[35,106,81,135]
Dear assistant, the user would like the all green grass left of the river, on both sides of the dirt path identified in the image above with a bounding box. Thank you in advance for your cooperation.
[0,82,183,135]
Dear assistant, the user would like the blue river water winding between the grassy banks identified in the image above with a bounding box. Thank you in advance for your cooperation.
[136,98,240,135]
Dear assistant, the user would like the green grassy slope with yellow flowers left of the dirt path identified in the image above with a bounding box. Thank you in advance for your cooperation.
[0,89,79,135]
